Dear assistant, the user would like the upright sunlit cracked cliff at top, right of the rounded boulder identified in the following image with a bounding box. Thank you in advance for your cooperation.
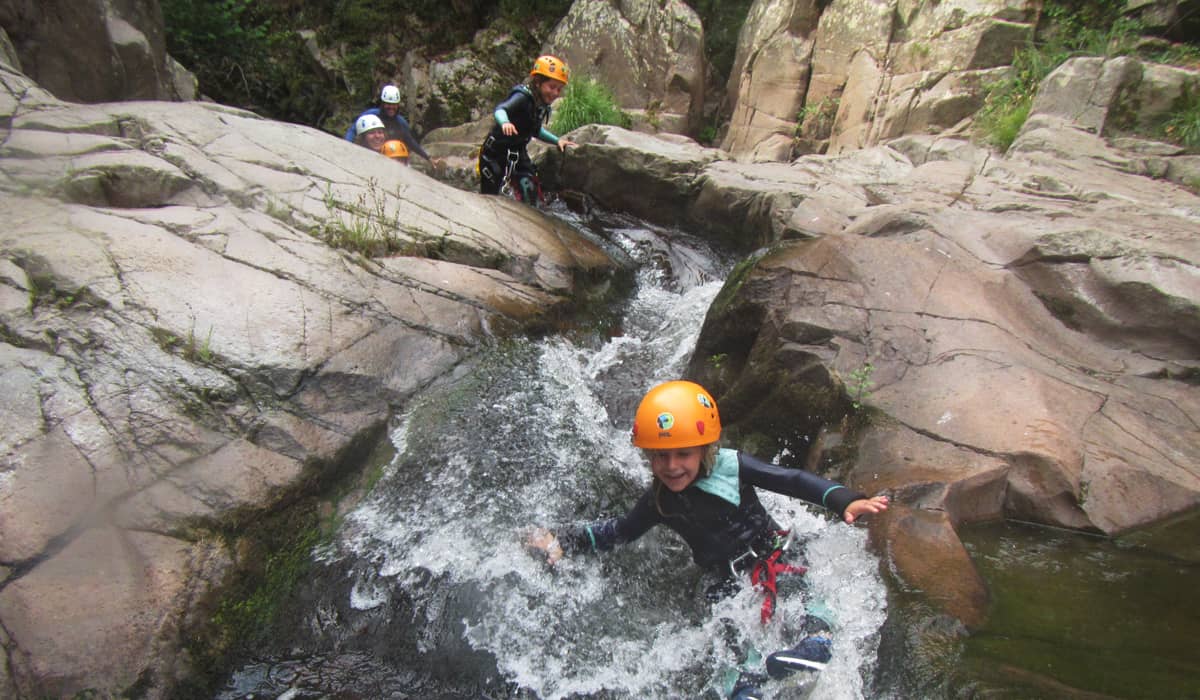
[722,0,1039,162]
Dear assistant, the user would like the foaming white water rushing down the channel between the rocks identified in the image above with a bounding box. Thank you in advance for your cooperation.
[220,211,886,700]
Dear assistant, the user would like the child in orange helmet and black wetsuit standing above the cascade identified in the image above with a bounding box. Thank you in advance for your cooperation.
[478,55,576,205]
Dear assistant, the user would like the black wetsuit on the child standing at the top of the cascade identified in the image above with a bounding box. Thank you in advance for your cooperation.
[479,85,558,204]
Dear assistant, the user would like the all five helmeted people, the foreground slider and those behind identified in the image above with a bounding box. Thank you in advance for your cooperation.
[346,55,888,700]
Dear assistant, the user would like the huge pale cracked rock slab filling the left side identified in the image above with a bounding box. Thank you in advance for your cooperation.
[0,48,612,698]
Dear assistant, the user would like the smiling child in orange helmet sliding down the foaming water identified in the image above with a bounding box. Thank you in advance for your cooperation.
[527,381,888,700]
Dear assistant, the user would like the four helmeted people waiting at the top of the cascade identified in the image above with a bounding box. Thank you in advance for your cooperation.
[346,55,575,204]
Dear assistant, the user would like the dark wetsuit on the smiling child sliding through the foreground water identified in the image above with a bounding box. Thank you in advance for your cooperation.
[559,449,865,574]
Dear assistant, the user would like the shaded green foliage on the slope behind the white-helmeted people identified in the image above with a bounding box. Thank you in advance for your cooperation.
[161,0,571,132]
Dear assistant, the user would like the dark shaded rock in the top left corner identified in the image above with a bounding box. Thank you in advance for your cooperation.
[0,0,196,102]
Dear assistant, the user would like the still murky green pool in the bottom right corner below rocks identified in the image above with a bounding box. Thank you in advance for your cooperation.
[950,515,1200,699]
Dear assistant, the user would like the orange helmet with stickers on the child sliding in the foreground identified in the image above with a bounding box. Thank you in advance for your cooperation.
[634,381,721,449]
